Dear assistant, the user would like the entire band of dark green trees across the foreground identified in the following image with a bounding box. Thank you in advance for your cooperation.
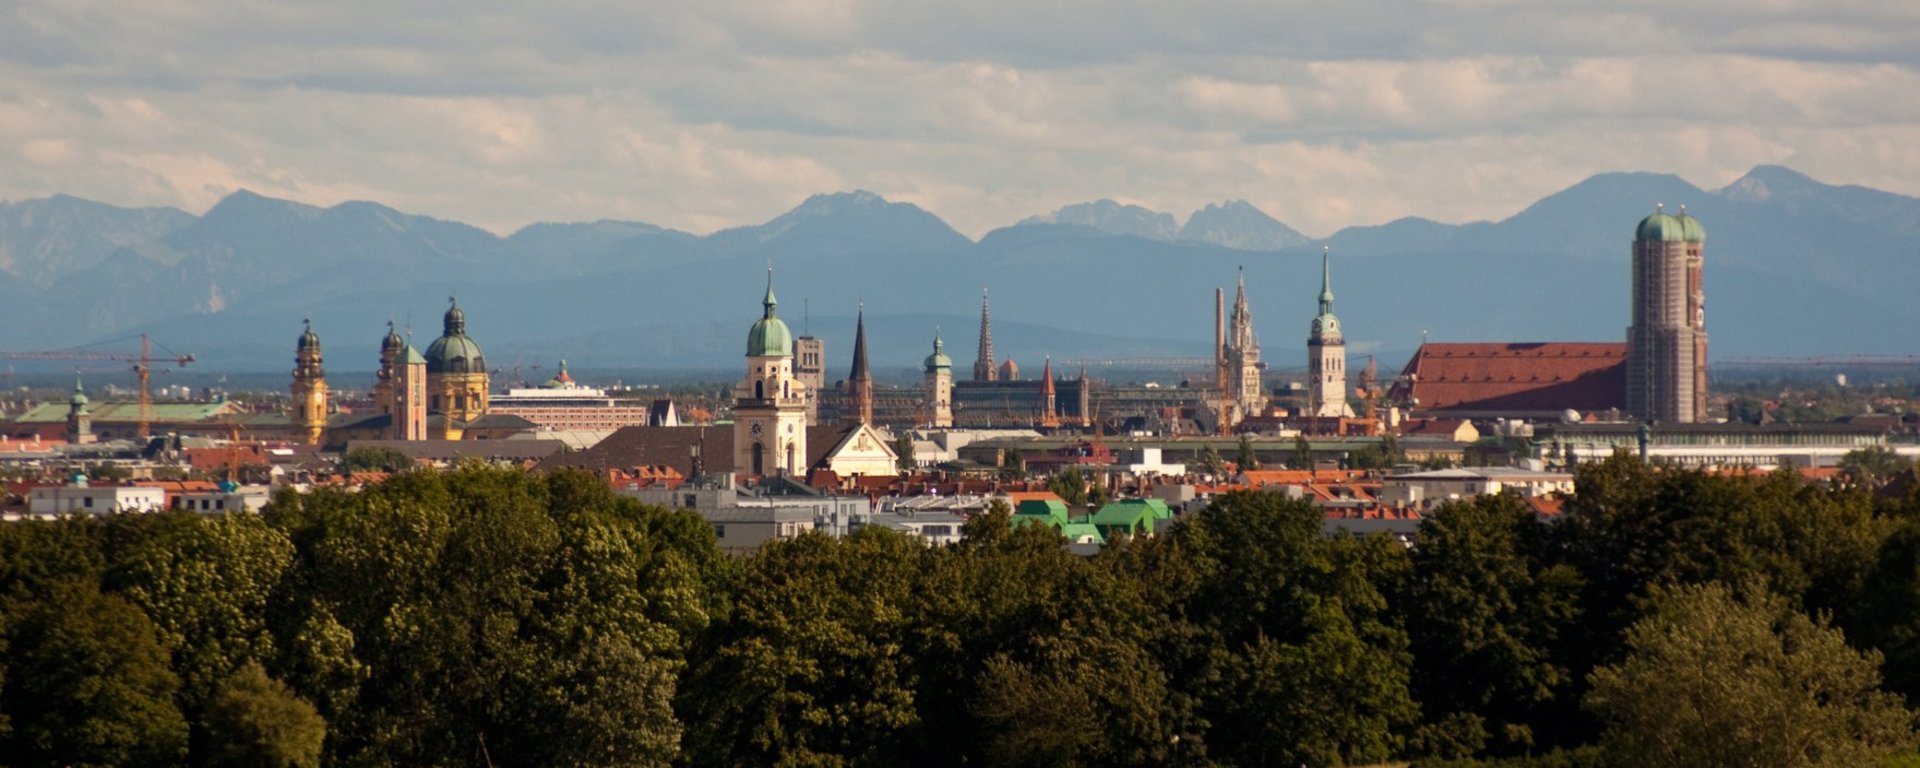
[0,457,1920,766]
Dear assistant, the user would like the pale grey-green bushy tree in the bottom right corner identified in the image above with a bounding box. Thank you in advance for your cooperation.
[1586,584,1916,768]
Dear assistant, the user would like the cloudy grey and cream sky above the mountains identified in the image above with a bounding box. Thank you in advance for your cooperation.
[0,0,1920,236]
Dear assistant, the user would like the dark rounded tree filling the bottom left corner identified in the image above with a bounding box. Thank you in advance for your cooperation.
[0,582,186,766]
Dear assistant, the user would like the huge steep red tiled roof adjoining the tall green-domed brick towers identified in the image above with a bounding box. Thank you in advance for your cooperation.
[1394,342,1626,413]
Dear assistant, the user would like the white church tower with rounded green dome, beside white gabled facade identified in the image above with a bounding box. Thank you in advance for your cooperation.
[733,267,806,476]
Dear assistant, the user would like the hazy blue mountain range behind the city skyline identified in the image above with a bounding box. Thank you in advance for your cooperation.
[0,165,1920,380]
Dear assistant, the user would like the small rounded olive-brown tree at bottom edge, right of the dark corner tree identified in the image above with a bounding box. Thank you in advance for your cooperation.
[205,662,326,768]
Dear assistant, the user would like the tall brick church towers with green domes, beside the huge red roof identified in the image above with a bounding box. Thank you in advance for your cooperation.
[1626,207,1707,422]
